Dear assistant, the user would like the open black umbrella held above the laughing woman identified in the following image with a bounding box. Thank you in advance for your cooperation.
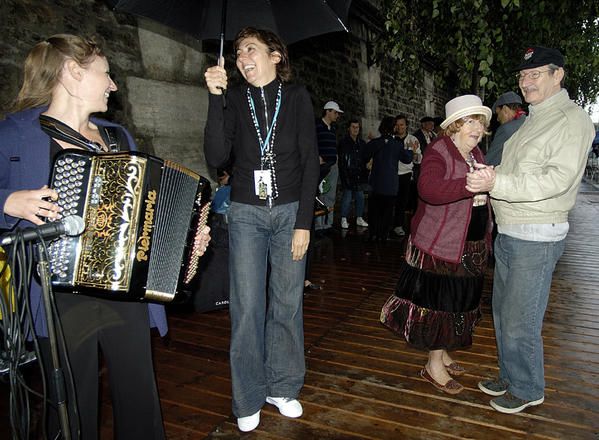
[112,0,351,55]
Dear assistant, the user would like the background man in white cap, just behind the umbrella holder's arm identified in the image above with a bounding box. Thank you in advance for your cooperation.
[314,101,343,230]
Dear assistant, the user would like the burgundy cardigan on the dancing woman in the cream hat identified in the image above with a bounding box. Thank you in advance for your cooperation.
[411,136,492,263]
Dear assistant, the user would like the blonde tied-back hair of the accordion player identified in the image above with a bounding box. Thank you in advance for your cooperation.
[12,34,104,111]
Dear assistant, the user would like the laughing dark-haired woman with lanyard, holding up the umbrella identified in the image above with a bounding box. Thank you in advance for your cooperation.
[204,28,319,431]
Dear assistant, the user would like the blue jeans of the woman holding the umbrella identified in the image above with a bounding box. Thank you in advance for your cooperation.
[228,202,306,417]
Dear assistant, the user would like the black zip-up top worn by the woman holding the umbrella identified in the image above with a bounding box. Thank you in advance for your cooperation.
[204,80,319,229]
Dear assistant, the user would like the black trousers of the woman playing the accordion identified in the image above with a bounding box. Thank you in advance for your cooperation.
[40,293,165,440]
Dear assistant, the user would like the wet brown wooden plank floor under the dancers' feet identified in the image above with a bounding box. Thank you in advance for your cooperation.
[142,186,599,440]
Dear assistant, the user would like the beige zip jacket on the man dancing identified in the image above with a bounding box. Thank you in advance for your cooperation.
[490,89,595,225]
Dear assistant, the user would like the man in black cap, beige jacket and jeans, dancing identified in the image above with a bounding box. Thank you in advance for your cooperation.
[466,46,595,414]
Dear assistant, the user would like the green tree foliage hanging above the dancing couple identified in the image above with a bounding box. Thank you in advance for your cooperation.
[377,0,599,105]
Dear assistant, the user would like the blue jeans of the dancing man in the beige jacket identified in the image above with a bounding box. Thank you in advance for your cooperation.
[493,234,566,401]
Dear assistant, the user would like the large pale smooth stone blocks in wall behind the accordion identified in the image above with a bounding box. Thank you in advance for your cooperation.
[126,20,209,175]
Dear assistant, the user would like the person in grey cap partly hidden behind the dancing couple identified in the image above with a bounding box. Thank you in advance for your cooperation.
[485,92,526,166]
